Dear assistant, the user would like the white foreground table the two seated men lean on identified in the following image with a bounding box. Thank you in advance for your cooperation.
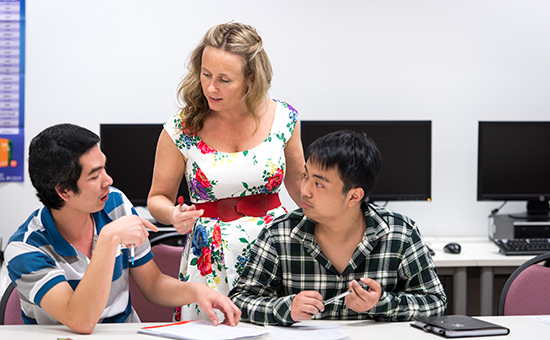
[0,316,550,340]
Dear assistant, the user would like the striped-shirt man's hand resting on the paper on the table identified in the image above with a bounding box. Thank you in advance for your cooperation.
[196,284,241,326]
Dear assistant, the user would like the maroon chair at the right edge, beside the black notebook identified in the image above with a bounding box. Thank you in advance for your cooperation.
[497,252,550,315]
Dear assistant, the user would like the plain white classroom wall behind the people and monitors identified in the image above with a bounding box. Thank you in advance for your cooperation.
[0,0,550,248]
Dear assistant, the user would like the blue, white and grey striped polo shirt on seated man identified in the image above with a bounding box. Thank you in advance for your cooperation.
[5,187,153,324]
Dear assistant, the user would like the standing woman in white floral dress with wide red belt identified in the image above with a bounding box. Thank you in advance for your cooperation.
[148,23,304,320]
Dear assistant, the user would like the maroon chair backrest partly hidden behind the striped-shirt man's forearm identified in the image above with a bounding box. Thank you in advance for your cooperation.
[130,243,183,322]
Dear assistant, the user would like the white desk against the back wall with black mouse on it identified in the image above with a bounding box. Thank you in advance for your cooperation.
[424,237,534,315]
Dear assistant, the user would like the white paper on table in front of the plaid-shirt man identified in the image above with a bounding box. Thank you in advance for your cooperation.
[265,324,349,340]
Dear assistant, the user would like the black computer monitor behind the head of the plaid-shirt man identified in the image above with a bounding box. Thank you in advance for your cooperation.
[300,120,432,202]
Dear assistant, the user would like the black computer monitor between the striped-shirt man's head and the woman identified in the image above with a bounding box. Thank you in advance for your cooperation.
[99,124,190,206]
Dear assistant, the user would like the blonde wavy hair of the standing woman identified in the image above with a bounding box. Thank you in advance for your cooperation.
[177,22,273,134]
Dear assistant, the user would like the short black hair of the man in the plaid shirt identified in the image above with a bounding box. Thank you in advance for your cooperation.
[306,130,382,199]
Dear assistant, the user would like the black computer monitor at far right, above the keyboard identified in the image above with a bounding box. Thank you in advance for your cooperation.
[477,121,550,218]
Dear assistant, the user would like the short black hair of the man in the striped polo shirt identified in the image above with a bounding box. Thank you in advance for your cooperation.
[29,124,100,209]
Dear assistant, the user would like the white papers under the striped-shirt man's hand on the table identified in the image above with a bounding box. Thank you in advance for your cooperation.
[138,320,267,340]
